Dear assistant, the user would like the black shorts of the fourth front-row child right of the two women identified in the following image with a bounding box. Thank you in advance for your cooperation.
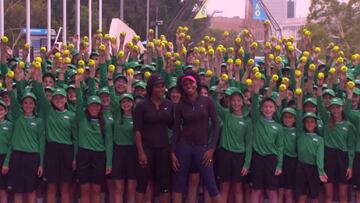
[295,162,321,199]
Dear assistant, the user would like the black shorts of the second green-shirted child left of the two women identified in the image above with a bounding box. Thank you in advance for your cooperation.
[76,148,106,185]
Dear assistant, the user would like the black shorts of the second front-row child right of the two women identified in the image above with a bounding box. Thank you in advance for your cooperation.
[249,151,279,190]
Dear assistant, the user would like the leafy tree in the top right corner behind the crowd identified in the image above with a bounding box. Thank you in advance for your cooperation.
[306,0,360,55]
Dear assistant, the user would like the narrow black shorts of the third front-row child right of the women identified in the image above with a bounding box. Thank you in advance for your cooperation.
[279,155,297,190]
